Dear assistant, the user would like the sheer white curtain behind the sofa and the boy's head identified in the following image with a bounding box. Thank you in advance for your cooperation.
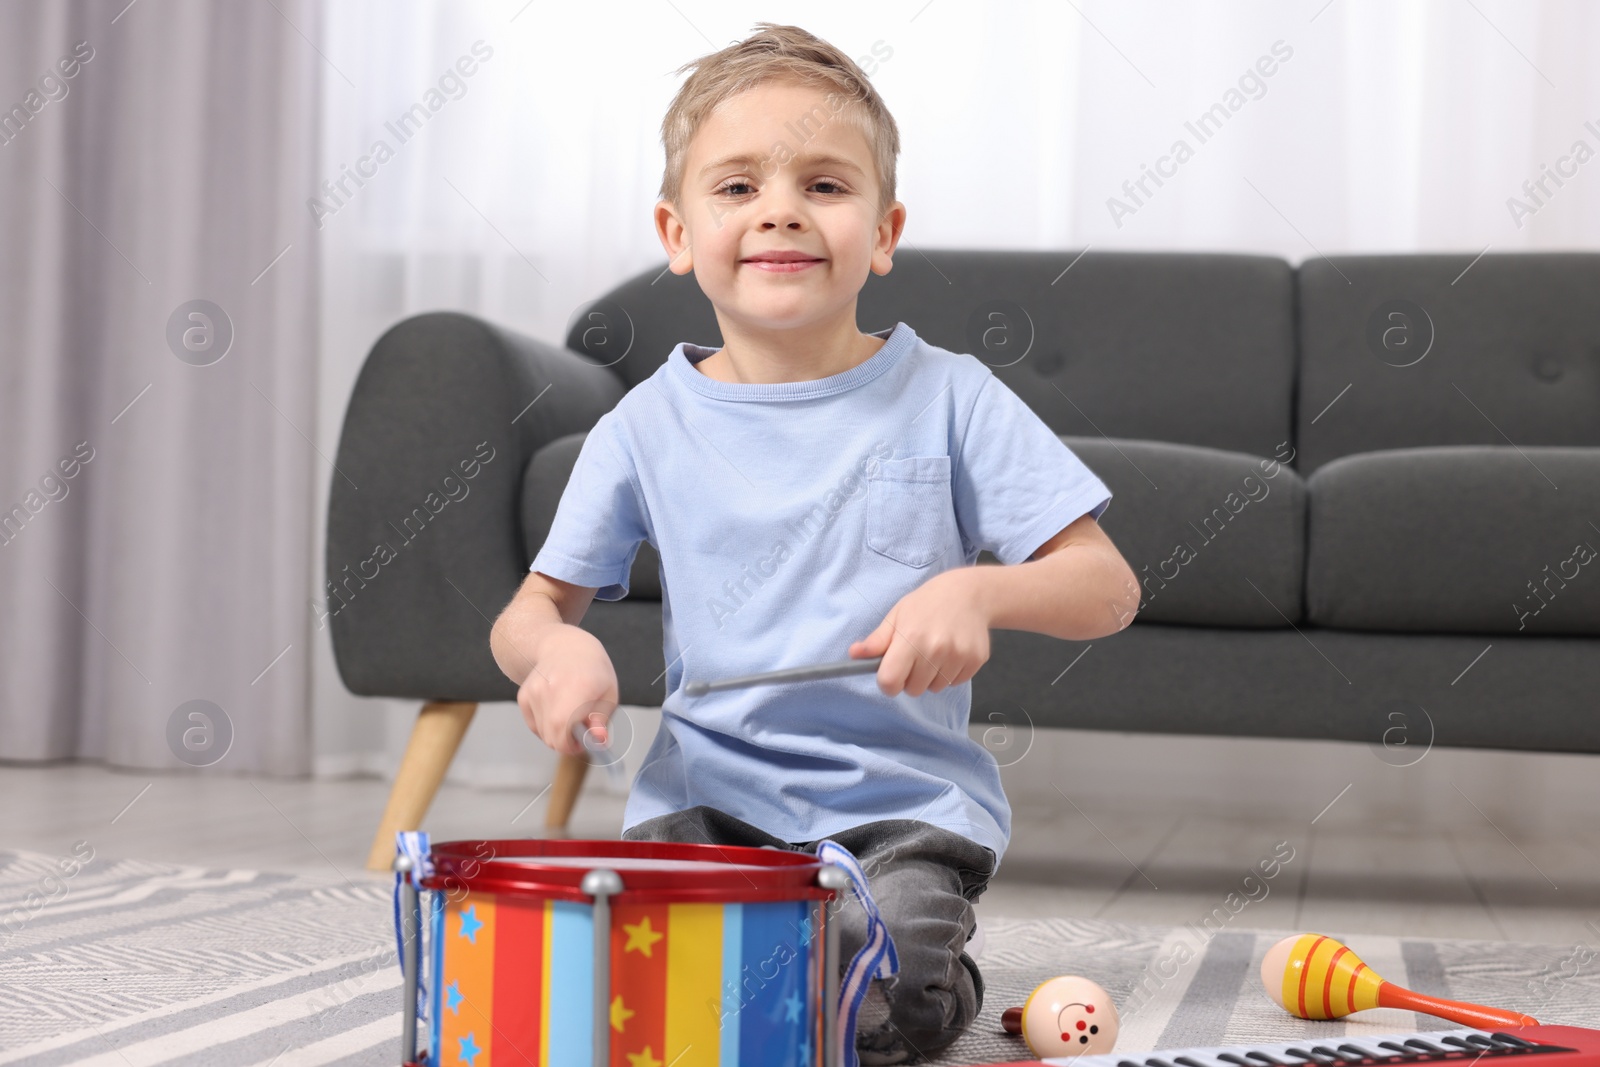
[307,0,1600,781]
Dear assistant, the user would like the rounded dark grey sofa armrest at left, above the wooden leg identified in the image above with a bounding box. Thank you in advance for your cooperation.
[324,312,627,701]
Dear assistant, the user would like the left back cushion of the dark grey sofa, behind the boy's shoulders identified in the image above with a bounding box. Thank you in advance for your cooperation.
[568,254,1294,456]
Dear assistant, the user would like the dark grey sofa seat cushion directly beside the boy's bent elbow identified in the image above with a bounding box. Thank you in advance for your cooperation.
[1061,437,1306,627]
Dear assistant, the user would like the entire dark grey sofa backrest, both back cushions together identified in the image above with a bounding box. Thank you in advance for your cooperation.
[568,246,1600,475]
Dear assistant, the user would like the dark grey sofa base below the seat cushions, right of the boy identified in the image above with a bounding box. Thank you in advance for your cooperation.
[979,620,1600,755]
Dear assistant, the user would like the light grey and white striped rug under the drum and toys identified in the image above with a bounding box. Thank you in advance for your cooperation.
[0,853,1600,1067]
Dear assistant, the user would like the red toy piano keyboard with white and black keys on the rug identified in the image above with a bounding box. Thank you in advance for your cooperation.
[966,1025,1600,1067]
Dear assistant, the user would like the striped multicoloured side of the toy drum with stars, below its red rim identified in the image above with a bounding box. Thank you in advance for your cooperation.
[429,863,822,1067]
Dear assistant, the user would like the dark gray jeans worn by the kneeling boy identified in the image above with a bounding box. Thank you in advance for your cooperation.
[622,805,995,1064]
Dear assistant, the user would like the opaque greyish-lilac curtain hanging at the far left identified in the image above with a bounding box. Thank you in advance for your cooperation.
[0,0,323,780]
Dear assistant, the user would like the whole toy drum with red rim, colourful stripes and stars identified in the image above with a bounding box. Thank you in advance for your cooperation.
[395,833,854,1067]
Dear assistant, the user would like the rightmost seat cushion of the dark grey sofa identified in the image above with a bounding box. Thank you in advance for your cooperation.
[1306,446,1600,635]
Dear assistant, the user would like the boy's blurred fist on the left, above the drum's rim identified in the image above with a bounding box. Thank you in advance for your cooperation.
[517,624,618,755]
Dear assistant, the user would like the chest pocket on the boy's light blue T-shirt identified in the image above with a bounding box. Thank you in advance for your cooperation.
[867,456,957,568]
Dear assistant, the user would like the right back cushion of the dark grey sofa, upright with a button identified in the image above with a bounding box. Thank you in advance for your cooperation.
[1296,253,1600,475]
